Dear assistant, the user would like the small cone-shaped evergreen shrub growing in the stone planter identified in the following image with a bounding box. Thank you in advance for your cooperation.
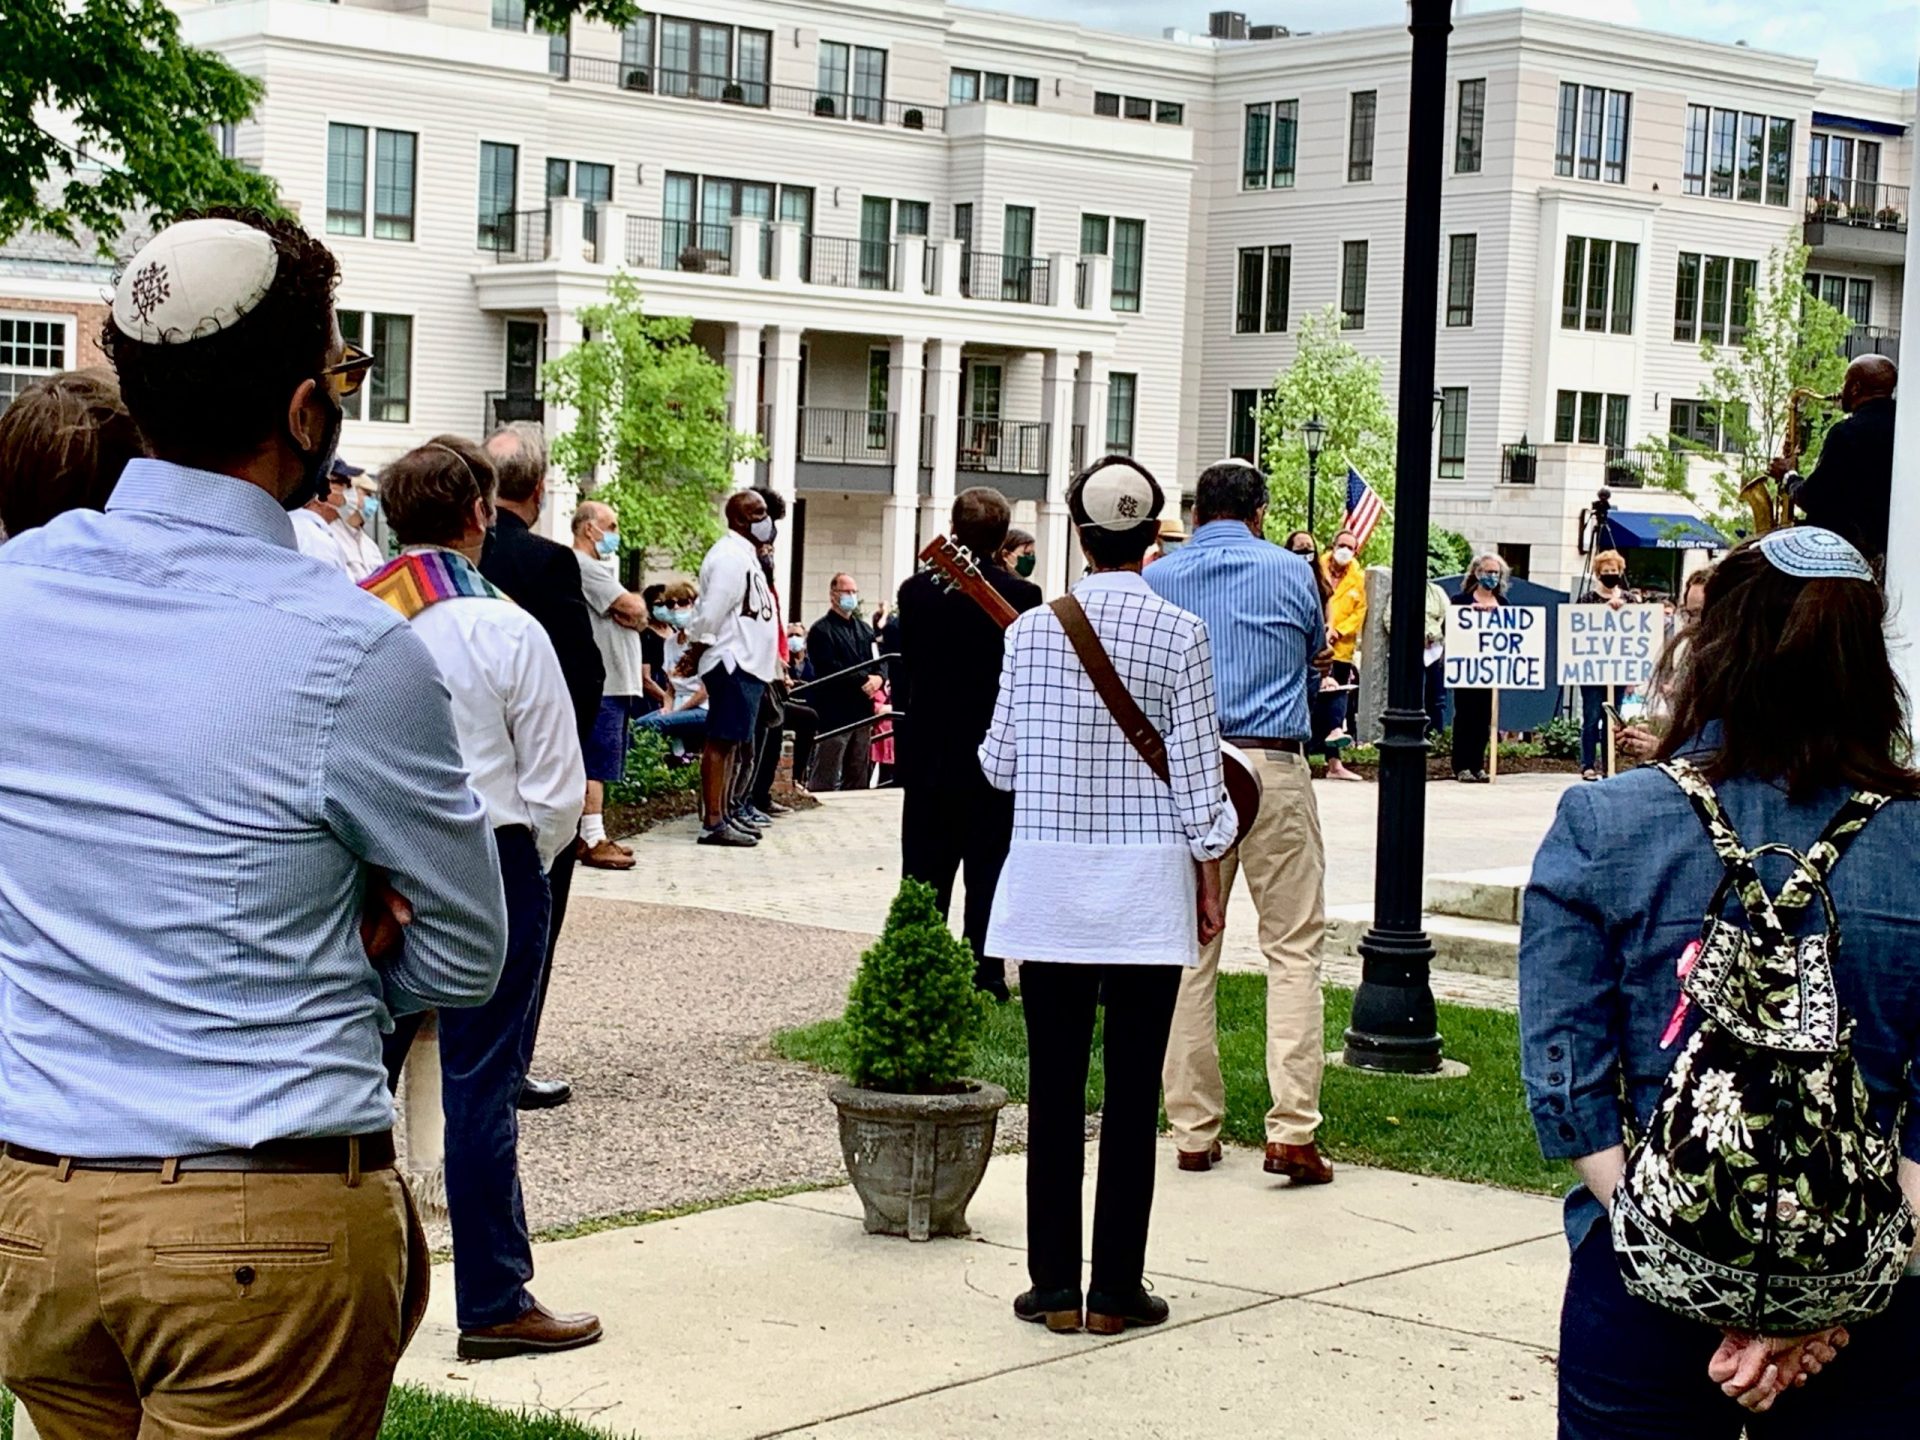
[847,879,991,1094]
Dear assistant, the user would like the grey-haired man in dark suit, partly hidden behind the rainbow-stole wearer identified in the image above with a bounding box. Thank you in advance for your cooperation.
[480,420,607,1110]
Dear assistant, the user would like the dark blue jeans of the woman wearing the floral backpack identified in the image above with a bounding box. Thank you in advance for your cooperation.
[1559,1223,1920,1440]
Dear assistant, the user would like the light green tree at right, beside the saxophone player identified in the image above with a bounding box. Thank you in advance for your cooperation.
[1663,240,1853,534]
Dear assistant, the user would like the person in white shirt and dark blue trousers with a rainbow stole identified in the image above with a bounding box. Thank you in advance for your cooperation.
[361,436,601,1359]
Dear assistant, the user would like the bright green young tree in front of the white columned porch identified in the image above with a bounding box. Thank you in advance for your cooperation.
[541,271,766,564]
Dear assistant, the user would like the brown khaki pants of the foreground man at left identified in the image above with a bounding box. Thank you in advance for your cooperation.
[0,1158,428,1440]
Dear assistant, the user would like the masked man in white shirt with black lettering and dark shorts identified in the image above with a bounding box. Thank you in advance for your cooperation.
[674,490,780,847]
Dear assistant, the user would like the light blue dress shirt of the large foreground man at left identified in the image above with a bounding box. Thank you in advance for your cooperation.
[0,461,507,1158]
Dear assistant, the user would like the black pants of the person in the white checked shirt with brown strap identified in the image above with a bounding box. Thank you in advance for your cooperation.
[1020,960,1181,1296]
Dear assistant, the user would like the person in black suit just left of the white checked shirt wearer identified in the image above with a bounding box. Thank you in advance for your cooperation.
[893,486,1041,1000]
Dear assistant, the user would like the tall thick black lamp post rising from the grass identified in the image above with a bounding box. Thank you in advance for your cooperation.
[1346,0,1453,1075]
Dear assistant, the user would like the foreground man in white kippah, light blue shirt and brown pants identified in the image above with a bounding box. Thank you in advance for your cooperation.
[0,213,507,1440]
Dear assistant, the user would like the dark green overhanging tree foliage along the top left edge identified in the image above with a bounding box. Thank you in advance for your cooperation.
[0,0,636,253]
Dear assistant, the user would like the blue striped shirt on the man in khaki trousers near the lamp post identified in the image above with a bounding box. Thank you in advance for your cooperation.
[1146,520,1327,739]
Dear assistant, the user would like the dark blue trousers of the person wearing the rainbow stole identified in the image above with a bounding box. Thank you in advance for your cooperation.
[386,826,549,1331]
